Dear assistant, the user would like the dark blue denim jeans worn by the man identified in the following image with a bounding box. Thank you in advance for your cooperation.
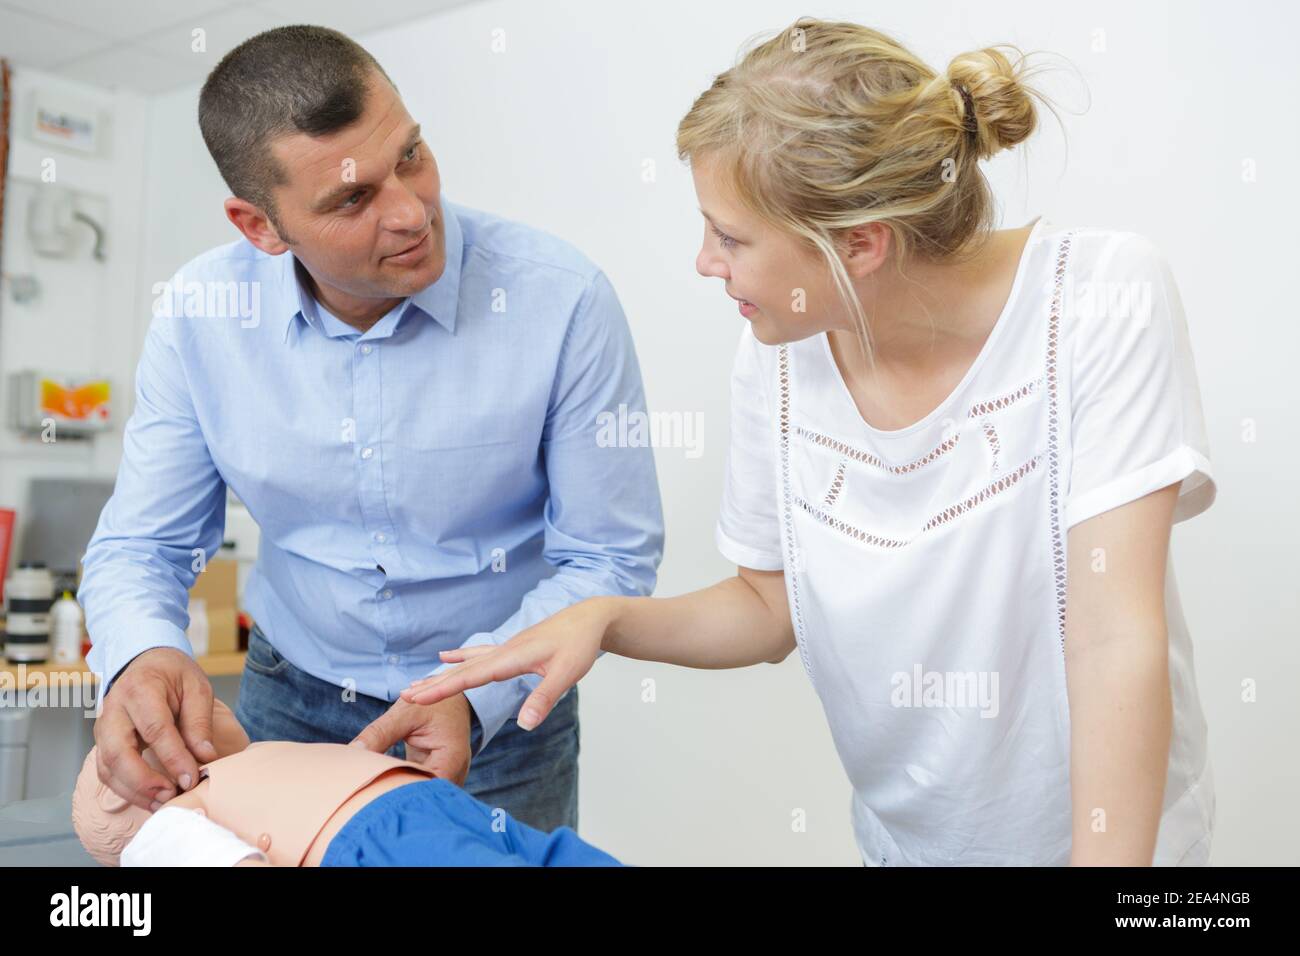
[235,626,579,832]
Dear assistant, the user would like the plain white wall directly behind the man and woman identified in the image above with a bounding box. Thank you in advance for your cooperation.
[140,0,1300,864]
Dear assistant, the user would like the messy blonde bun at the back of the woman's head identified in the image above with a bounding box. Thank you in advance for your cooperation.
[948,47,1039,159]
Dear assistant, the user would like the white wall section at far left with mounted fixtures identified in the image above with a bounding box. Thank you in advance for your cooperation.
[0,68,147,554]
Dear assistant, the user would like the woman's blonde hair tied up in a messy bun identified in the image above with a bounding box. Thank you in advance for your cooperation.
[677,17,1047,355]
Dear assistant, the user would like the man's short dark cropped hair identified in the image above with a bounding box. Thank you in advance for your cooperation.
[199,26,397,229]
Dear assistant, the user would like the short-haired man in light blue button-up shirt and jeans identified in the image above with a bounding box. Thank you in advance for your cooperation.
[78,26,663,830]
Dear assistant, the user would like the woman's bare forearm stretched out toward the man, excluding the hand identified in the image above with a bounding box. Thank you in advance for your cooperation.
[597,571,794,669]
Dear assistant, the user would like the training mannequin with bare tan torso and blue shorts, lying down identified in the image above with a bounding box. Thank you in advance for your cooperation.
[73,700,619,866]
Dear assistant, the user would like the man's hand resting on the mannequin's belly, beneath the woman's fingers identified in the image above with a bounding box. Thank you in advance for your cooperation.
[351,693,471,787]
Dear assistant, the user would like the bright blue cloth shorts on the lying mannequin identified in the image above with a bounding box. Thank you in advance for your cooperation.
[321,778,623,866]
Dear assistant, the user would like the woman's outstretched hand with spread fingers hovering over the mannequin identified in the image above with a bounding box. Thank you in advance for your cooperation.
[402,597,618,730]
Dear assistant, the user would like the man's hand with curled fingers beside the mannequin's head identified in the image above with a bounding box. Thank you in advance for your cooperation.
[95,648,217,810]
